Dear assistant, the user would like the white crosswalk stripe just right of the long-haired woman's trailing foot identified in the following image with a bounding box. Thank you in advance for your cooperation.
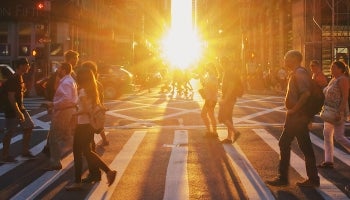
[85,131,147,200]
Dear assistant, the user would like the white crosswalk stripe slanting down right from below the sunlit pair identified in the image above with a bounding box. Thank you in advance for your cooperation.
[218,130,275,200]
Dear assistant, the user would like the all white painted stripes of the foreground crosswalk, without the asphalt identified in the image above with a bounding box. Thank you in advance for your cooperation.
[0,127,350,200]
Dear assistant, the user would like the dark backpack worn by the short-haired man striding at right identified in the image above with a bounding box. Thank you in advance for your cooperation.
[294,70,325,117]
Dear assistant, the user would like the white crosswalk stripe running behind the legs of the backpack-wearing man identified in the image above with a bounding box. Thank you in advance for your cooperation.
[253,129,349,200]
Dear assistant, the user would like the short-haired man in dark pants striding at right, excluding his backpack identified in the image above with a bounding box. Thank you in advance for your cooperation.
[267,50,320,187]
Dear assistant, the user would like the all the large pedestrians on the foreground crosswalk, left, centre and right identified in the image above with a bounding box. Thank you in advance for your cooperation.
[1,50,350,192]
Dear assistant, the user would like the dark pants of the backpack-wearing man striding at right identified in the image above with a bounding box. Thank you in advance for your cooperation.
[279,112,319,181]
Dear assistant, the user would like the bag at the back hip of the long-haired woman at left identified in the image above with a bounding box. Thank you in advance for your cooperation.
[89,104,107,134]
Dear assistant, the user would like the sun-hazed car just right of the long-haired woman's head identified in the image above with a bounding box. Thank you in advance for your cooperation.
[98,64,134,99]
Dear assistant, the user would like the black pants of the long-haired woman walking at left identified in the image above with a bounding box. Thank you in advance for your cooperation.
[73,124,110,183]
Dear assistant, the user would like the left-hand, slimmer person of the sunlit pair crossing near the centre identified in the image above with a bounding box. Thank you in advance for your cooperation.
[201,63,219,138]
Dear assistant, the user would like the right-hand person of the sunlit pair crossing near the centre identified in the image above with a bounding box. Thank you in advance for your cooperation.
[218,59,243,144]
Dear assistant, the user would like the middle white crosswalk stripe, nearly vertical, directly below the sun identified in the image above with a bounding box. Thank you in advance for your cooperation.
[163,130,189,200]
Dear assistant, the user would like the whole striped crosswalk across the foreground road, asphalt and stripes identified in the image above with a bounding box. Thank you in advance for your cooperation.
[0,127,350,200]
